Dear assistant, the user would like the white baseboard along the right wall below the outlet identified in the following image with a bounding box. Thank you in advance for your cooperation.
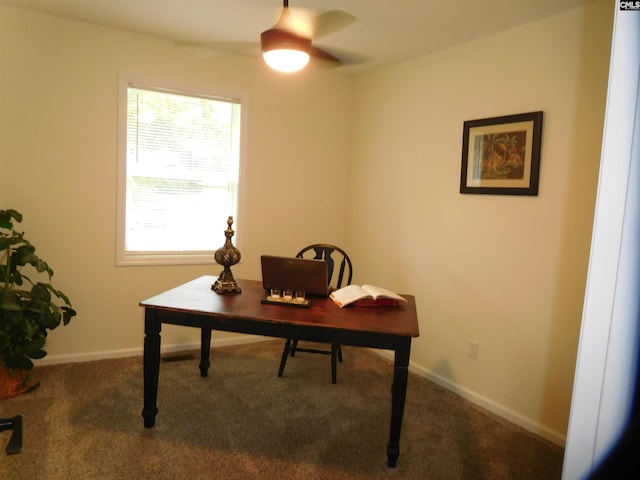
[372,349,567,447]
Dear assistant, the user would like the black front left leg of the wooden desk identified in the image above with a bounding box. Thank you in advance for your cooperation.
[142,308,162,428]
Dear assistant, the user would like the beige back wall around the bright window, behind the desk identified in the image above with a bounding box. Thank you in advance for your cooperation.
[0,7,351,361]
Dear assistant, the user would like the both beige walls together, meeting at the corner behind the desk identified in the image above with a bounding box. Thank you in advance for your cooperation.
[0,0,612,442]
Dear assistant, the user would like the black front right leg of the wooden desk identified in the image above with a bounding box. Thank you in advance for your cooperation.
[387,338,411,468]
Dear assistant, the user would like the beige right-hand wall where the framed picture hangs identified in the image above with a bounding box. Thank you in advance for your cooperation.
[349,1,613,442]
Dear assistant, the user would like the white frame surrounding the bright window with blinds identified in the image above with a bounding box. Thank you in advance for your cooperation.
[115,74,248,266]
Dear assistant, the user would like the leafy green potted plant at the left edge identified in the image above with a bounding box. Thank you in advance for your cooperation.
[0,210,76,397]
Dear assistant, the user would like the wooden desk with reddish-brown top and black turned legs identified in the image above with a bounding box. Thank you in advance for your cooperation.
[140,276,418,467]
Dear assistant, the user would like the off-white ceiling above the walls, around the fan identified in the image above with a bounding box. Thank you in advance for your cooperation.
[0,0,595,73]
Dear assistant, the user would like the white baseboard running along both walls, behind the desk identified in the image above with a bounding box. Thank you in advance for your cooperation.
[37,334,566,447]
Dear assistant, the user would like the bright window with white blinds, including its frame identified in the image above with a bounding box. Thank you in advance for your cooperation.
[116,83,241,265]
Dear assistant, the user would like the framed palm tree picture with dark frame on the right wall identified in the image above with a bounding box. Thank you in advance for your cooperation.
[460,112,542,195]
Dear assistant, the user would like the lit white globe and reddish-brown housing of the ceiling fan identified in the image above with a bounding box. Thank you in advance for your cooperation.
[260,28,311,73]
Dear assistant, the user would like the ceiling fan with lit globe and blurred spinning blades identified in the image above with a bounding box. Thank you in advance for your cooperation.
[260,0,355,72]
